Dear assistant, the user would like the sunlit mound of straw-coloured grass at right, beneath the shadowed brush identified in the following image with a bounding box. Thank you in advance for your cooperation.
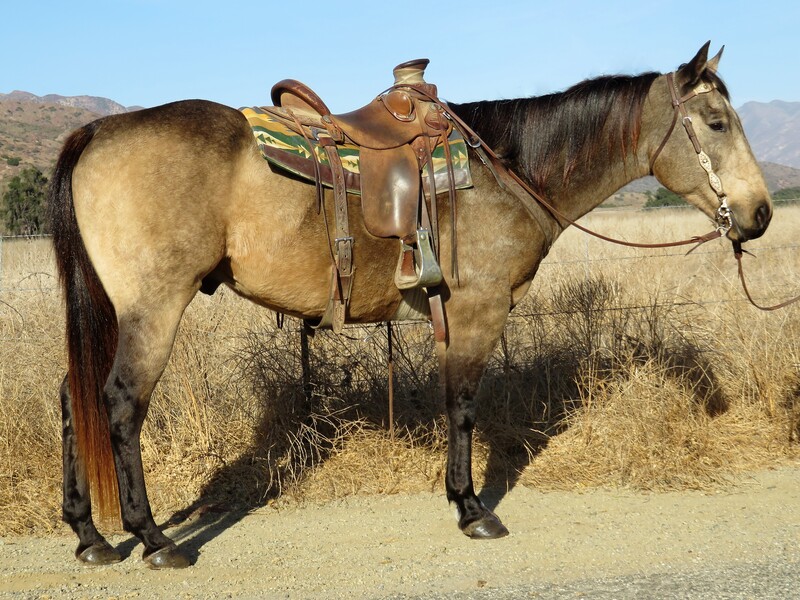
[522,361,774,490]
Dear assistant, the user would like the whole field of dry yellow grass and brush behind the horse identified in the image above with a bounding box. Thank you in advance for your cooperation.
[0,207,800,535]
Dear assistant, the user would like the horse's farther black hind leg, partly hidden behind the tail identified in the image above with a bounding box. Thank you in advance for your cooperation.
[61,377,122,565]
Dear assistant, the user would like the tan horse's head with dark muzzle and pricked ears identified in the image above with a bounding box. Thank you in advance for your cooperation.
[642,42,772,242]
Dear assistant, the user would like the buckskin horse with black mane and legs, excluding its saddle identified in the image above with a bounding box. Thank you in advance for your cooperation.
[50,44,772,568]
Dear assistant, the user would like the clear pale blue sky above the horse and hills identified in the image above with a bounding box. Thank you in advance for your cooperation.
[0,0,800,112]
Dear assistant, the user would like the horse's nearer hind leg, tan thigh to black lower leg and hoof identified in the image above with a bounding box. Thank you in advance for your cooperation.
[104,296,196,568]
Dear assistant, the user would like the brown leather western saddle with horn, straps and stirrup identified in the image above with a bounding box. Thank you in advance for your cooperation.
[261,59,466,332]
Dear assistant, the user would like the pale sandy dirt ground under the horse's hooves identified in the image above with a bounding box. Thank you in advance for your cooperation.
[0,463,800,599]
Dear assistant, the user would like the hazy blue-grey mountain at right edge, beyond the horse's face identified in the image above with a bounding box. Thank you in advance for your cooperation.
[738,100,800,169]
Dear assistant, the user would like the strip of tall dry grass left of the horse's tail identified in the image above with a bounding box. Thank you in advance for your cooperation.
[0,240,64,535]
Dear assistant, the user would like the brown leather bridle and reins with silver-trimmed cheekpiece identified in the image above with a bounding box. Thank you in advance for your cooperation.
[421,73,800,311]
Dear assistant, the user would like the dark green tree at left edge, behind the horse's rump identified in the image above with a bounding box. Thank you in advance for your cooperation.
[2,167,50,235]
